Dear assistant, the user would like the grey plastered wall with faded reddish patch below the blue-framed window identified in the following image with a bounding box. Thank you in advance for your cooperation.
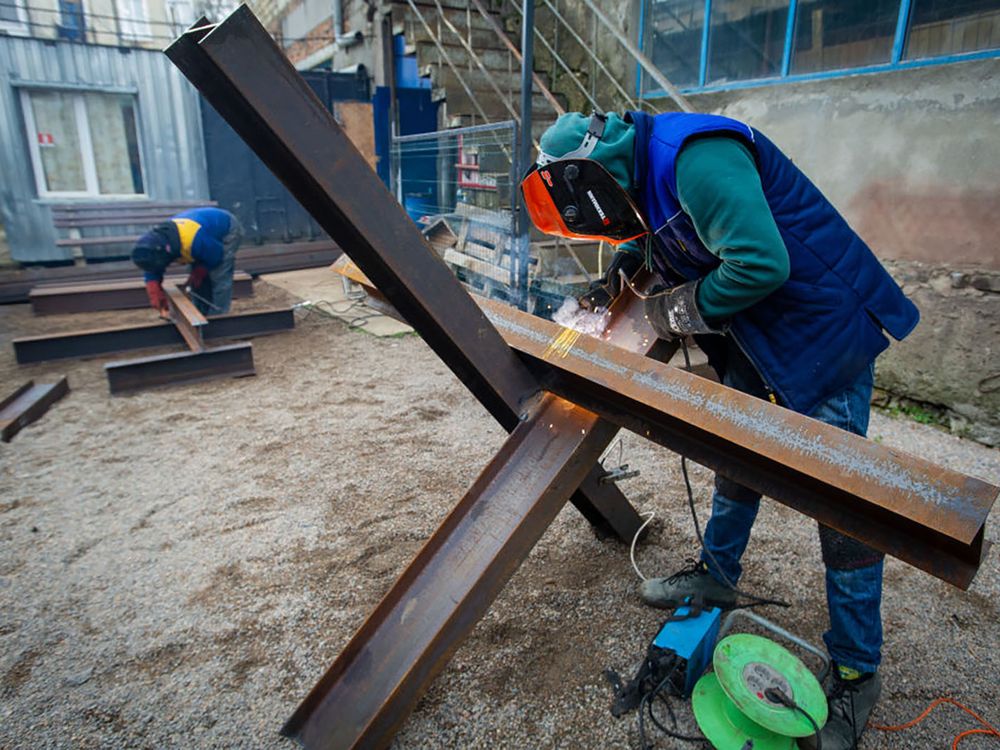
[689,59,1000,269]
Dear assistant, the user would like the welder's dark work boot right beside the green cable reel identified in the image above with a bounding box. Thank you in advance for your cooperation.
[799,667,882,750]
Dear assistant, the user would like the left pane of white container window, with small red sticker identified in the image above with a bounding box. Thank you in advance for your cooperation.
[28,91,87,193]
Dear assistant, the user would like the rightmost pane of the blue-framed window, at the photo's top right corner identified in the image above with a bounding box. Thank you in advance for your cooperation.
[905,0,1000,60]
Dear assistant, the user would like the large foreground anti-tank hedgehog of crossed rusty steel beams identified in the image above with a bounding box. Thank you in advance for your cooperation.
[167,6,998,748]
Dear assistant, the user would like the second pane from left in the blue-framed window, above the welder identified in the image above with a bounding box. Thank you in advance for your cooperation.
[708,0,788,83]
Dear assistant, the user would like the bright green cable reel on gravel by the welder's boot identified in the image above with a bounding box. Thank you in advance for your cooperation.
[691,633,828,750]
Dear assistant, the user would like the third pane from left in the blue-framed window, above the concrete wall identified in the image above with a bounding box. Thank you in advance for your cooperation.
[792,0,899,73]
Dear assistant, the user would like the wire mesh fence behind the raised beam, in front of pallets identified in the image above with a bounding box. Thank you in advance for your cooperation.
[390,122,613,317]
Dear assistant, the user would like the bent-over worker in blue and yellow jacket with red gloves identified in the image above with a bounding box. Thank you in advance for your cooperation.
[132,207,243,315]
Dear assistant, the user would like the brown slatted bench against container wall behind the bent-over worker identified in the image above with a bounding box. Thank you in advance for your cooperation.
[52,200,216,260]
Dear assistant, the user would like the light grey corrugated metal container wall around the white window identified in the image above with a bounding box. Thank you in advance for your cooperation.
[0,36,208,263]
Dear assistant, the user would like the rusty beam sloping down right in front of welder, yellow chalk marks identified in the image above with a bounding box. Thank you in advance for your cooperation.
[480,292,1000,589]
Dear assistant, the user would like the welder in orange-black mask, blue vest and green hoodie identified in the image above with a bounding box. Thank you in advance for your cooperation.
[522,112,919,750]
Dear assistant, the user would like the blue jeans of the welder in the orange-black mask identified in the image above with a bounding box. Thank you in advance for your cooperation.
[702,354,883,672]
